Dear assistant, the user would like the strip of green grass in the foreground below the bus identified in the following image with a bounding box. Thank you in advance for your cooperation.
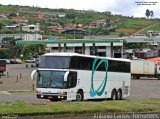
[0,99,160,115]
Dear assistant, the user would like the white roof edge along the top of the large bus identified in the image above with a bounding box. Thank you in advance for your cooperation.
[42,52,130,62]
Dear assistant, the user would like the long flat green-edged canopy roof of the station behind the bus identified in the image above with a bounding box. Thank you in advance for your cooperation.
[16,38,126,45]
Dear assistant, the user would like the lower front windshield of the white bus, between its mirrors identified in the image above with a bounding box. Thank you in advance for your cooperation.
[37,70,65,88]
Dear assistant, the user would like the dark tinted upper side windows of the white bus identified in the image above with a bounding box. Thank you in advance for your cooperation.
[70,56,130,73]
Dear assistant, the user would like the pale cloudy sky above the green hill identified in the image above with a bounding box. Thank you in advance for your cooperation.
[0,0,160,18]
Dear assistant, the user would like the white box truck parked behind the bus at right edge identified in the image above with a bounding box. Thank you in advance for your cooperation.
[131,60,160,79]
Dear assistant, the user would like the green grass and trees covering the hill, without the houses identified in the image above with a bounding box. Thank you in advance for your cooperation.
[0,5,160,35]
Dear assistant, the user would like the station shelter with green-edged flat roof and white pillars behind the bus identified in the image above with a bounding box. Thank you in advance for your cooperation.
[16,38,126,57]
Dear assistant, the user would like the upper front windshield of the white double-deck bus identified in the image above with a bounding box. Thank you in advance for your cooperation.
[39,56,70,69]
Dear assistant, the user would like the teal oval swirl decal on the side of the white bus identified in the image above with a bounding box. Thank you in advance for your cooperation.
[90,58,108,97]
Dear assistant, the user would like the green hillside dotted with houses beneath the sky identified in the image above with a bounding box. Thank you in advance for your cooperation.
[0,5,160,37]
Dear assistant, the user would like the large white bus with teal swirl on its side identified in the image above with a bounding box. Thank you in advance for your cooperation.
[31,53,131,101]
